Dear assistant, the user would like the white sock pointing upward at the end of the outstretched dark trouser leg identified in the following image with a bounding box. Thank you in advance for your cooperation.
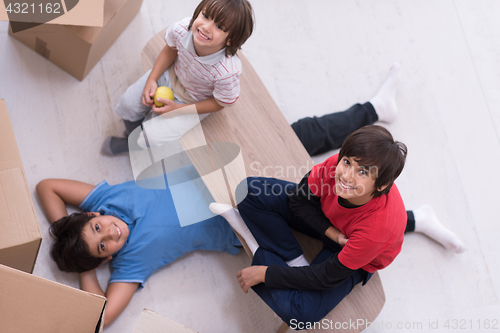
[370,62,401,123]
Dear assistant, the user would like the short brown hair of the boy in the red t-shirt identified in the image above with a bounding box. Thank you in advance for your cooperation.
[338,125,408,198]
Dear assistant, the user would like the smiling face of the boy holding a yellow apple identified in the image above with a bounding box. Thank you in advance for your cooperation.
[191,10,229,57]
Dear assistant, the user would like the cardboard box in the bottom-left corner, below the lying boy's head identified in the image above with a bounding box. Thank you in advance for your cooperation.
[0,265,106,333]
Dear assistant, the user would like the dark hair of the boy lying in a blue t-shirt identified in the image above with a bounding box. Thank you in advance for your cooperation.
[49,213,106,273]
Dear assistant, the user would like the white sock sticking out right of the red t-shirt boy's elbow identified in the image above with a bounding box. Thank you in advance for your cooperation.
[413,205,465,253]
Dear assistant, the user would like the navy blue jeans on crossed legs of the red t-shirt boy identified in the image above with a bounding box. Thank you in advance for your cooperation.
[236,177,371,325]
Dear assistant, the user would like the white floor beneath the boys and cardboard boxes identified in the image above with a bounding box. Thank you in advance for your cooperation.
[0,0,500,333]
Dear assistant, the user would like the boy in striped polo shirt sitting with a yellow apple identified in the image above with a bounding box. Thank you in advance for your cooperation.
[103,0,254,155]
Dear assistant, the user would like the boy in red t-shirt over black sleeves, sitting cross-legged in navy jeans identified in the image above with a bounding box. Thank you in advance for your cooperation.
[210,125,463,328]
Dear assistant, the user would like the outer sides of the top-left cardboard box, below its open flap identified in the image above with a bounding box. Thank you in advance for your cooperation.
[9,0,142,81]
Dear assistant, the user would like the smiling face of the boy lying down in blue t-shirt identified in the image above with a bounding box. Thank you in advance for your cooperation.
[82,213,129,258]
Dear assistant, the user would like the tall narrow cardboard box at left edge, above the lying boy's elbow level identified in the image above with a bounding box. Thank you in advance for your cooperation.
[0,99,42,272]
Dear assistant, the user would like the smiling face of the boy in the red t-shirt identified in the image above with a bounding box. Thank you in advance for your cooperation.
[335,156,386,206]
